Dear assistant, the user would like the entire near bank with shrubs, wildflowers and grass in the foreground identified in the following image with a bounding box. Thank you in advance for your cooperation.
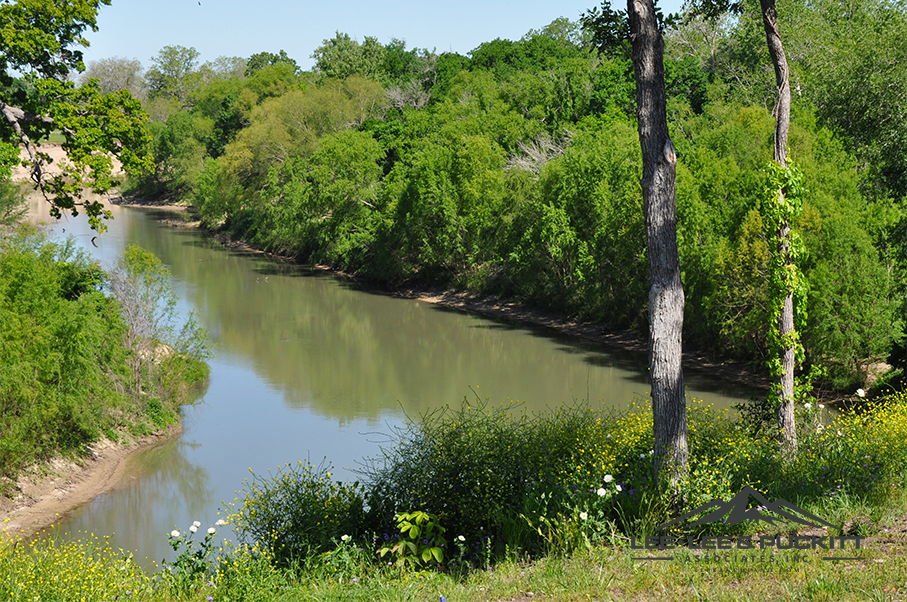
[0,393,907,602]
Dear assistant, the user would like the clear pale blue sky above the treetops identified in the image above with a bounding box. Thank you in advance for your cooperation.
[85,0,681,69]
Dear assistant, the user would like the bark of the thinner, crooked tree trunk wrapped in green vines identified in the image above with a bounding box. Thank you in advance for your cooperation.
[760,0,797,459]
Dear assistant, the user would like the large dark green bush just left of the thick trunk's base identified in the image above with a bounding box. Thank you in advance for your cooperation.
[365,403,652,557]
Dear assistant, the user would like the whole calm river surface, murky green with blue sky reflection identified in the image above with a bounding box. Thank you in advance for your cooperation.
[31,202,749,561]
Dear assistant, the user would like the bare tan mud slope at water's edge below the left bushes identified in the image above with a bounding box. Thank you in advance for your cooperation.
[0,424,182,538]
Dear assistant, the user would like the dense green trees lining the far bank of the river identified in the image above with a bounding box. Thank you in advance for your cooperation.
[129,7,905,388]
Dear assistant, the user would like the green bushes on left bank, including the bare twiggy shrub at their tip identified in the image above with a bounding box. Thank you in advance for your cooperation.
[0,229,207,487]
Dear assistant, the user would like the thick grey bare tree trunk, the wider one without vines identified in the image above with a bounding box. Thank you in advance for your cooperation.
[627,0,689,492]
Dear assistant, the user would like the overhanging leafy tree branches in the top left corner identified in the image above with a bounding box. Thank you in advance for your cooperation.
[0,0,150,231]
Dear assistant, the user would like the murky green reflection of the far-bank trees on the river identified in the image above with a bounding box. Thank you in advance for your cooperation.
[124,211,752,421]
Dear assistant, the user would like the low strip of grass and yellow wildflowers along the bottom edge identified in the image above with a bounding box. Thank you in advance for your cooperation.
[0,534,907,602]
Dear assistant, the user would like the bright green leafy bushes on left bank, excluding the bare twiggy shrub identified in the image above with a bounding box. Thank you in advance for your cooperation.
[0,227,125,476]
